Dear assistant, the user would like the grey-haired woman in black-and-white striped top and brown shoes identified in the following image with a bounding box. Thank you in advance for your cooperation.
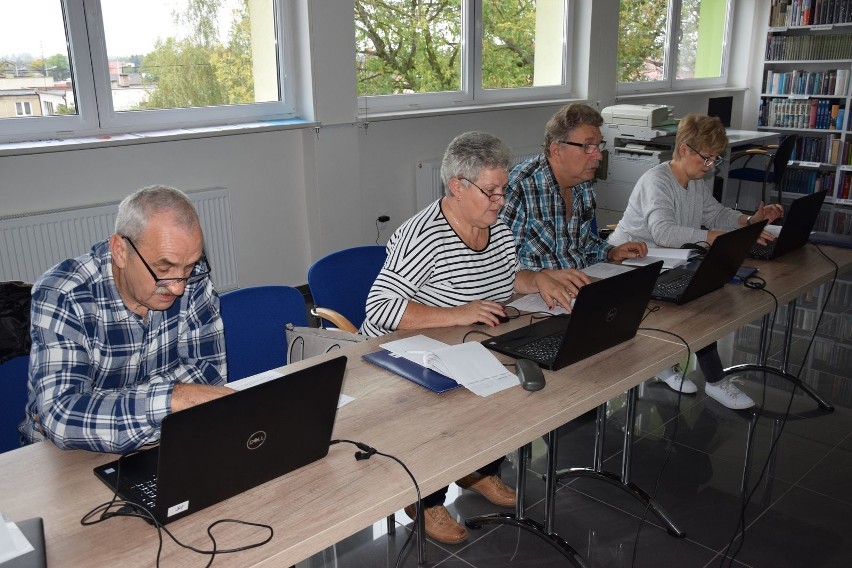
[361,132,571,544]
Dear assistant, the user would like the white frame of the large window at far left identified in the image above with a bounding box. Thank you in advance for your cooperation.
[0,0,296,142]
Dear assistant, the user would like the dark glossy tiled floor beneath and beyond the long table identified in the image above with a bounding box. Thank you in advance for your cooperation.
[299,264,852,568]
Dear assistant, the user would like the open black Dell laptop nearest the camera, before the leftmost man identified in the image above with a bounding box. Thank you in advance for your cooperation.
[94,357,346,524]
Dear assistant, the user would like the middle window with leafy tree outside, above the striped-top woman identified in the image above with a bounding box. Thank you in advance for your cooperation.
[355,0,570,112]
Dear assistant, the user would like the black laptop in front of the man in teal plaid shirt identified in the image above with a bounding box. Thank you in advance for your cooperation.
[651,221,766,304]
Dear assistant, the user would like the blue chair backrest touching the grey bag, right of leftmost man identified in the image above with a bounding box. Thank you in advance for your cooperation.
[219,286,308,381]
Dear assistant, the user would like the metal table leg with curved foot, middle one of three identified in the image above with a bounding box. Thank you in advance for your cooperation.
[556,386,686,538]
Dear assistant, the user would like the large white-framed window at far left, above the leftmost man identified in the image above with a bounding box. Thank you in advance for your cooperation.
[0,0,294,140]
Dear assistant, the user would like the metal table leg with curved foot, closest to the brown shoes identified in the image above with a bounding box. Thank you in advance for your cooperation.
[465,444,588,568]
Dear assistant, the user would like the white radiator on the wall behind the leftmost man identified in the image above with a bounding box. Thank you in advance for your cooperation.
[0,188,238,292]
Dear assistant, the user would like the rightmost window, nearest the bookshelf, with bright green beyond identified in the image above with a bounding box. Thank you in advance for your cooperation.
[617,0,733,94]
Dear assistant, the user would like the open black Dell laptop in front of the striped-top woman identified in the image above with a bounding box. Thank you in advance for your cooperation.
[482,260,663,371]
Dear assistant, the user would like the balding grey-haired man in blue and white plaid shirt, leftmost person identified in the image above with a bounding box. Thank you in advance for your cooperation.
[19,186,232,453]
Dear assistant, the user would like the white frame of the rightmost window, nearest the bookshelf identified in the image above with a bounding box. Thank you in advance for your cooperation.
[615,0,736,95]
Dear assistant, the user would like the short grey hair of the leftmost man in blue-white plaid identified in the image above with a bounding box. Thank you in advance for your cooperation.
[115,185,201,241]
